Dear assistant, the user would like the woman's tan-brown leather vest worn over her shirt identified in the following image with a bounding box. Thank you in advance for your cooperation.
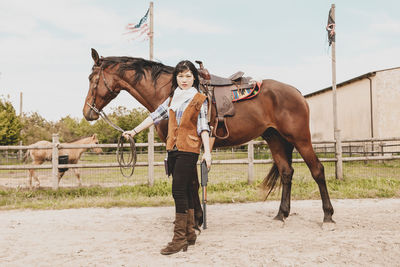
[167,93,207,154]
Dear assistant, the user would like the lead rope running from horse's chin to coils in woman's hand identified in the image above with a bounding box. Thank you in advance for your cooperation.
[86,103,137,178]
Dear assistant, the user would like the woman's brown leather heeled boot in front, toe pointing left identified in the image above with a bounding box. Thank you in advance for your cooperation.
[160,213,188,255]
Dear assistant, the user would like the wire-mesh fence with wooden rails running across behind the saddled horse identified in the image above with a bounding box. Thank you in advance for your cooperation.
[0,138,400,188]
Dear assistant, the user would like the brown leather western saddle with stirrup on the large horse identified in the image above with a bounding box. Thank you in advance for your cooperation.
[196,60,255,139]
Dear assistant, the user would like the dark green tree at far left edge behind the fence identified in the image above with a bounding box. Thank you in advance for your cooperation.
[0,98,22,145]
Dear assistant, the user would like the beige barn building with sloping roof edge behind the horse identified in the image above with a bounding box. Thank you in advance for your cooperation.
[305,67,400,141]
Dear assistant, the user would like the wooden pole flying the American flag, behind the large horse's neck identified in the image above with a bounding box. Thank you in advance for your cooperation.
[147,2,154,186]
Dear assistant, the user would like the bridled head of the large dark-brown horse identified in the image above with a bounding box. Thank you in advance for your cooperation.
[83,48,121,121]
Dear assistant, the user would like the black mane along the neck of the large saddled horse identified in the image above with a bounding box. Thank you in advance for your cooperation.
[97,57,174,84]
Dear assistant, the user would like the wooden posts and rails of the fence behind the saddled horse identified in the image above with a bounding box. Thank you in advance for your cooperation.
[0,135,400,189]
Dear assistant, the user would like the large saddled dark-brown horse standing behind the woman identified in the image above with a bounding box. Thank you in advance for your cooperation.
[83,49,334,226]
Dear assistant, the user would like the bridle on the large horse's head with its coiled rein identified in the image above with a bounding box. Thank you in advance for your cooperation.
[86,68,137,177]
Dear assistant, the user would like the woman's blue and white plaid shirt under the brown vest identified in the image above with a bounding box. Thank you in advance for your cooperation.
[150,97,210,136]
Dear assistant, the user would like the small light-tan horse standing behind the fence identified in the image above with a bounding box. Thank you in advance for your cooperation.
[24,134,103,188]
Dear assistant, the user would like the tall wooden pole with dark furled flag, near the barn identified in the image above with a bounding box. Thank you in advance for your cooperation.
[331,4,343,180]
